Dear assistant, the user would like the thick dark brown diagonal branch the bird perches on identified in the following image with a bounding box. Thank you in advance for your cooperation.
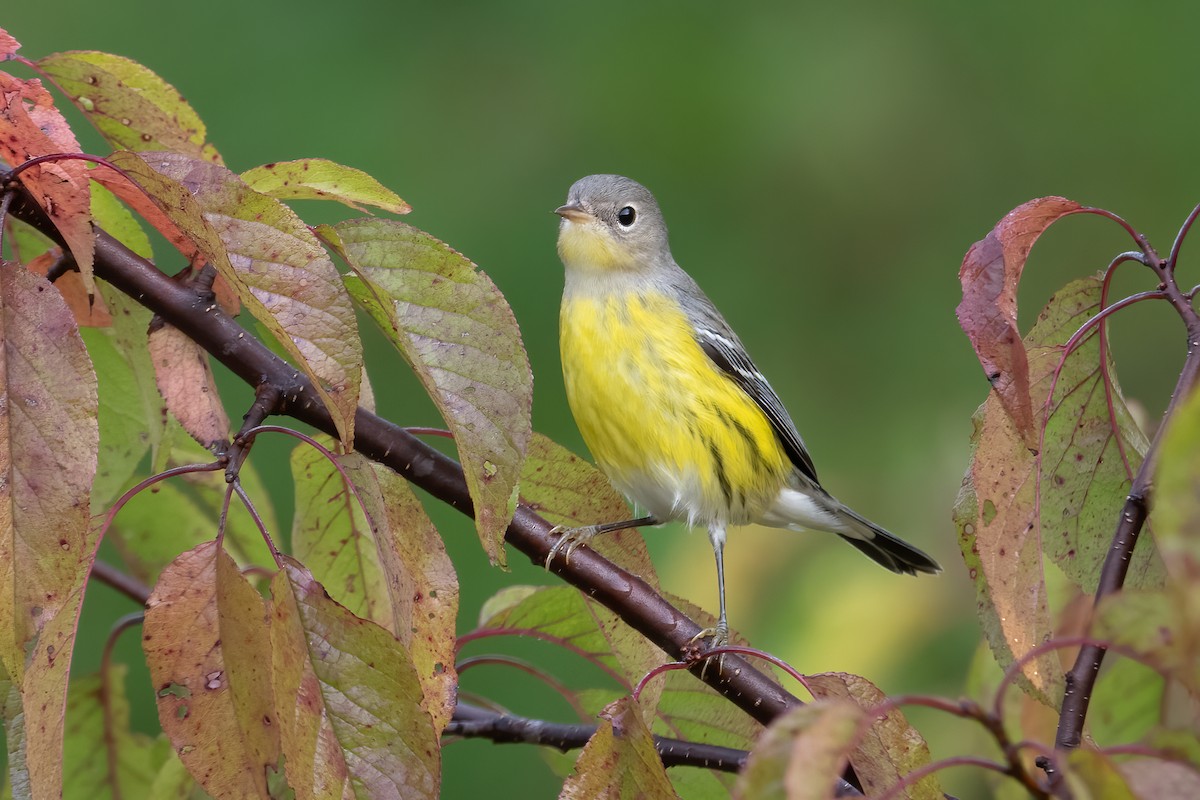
[11,190,800,724]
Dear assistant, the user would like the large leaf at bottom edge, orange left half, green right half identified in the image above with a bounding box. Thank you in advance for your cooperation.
[271,557,440,800]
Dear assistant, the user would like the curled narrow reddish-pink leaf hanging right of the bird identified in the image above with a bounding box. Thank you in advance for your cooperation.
[955,197,1082,450]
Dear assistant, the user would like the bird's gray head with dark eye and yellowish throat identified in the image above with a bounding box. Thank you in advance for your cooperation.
[554,175,671,272]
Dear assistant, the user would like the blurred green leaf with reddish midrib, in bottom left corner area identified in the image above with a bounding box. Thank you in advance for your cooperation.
[62,664,173,798]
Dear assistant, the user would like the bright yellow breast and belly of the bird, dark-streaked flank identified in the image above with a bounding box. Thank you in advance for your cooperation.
[560,290,791,524]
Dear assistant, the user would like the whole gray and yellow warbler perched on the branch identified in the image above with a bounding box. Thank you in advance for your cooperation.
[546,175,941,648]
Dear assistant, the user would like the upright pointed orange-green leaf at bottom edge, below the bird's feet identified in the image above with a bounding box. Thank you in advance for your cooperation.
[558,697,678,800]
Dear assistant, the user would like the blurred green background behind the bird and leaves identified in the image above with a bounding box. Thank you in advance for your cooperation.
[0,0,1200,798]
